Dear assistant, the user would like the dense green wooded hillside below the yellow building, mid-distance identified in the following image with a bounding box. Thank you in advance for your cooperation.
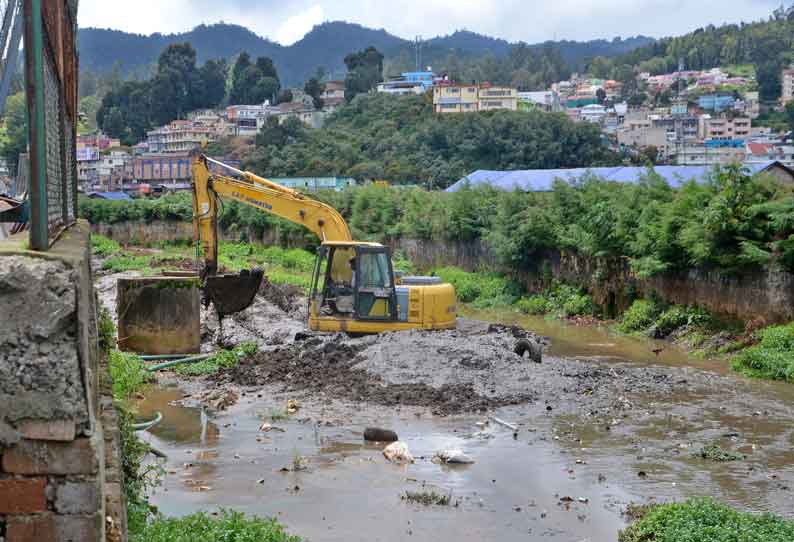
[243,93,618,188]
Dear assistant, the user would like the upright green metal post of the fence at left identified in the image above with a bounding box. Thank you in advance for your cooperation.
[25,0,49,250]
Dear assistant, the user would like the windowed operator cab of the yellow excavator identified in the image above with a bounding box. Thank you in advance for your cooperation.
[309,242,398,322]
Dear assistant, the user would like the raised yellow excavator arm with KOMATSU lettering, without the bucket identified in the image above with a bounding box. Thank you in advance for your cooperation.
[192,155,353,275]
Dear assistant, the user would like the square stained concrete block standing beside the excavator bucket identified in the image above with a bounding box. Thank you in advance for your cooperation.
[116,277,201,354]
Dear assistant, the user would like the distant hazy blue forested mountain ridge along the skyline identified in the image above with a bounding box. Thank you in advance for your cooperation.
[79,22,653,86]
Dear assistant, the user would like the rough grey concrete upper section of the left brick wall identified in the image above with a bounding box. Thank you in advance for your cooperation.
[0,254,90,425]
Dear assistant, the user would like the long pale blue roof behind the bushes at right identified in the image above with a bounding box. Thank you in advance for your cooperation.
[447,161,788,192]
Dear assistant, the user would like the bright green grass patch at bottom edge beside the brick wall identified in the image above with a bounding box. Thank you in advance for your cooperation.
[130,510,300,542]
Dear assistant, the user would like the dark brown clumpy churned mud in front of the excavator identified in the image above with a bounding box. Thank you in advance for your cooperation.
[222,336,532,415]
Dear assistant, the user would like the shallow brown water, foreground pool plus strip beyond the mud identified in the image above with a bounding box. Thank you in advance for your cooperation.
[138,312,794,542]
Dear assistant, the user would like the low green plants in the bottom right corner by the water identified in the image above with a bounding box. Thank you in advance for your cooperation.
[618,498,794,542]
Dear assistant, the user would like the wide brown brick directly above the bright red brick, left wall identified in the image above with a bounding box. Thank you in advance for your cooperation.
[3,438,99,474]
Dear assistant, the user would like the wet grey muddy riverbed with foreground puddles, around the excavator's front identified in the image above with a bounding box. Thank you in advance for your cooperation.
[97,266,794,541]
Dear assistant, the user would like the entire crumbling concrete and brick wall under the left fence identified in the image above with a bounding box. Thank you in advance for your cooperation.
[0,221,125,542]
